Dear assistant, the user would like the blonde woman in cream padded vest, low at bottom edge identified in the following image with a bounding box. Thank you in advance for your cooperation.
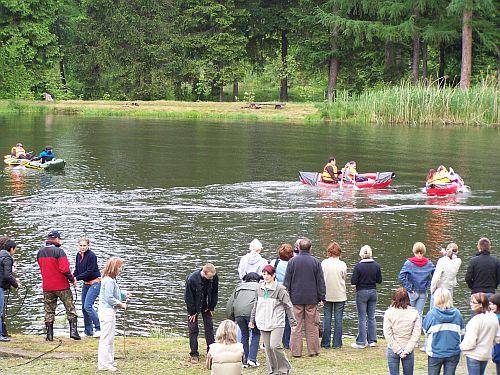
[206,319,243,375]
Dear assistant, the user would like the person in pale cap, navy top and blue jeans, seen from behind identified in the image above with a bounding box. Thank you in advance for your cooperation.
[351,245,382,349]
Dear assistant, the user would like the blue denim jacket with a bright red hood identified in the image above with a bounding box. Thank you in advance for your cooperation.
[399,257,435,293]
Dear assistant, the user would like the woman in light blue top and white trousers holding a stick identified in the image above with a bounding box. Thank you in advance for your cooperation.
[97,257,132,371]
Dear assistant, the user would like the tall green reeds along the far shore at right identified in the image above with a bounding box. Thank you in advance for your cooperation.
[319,82,500,126]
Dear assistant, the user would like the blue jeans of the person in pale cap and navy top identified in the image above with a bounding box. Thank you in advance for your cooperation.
[356,289,377,345]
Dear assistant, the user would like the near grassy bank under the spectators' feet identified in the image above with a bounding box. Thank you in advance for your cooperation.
[0,335,480,375]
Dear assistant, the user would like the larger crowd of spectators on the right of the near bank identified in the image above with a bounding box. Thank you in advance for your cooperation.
[185,237,500,375]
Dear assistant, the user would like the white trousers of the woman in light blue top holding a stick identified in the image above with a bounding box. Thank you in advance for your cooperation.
[97,308,116,370]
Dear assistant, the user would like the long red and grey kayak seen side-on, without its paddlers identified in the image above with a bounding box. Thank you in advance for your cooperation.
[299,172,396,189]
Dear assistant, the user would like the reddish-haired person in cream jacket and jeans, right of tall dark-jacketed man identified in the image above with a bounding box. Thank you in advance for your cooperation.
[321,242,347,348]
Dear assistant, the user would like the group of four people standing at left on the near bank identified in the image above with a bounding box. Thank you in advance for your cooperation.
[0,230,131,372]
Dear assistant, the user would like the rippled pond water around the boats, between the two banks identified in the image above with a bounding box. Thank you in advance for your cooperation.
[0,116,500,334]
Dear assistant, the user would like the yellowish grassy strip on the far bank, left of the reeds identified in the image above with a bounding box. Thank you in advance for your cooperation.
[0,100,322,122]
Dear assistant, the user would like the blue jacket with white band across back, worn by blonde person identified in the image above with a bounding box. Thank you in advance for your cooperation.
[422,307,465,358]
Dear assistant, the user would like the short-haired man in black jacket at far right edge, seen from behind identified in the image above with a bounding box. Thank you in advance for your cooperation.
[465,237,500,298]
